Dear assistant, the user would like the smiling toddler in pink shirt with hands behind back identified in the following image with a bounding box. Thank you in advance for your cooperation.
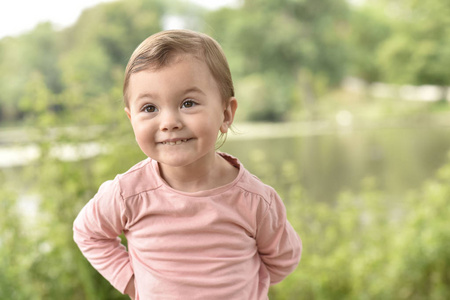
[73,30,301,300]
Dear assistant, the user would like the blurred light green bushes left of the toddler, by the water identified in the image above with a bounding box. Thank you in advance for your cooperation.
[0,101,138,300]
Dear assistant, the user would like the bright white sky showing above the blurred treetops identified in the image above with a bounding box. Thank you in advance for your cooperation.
[0,0,238,39]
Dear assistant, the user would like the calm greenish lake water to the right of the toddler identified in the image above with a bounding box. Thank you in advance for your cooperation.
[221,127,450,202]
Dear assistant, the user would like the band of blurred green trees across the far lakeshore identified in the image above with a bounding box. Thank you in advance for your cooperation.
[0,0,450,124]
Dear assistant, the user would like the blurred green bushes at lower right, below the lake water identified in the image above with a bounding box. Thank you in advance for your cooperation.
[271,158,450,300]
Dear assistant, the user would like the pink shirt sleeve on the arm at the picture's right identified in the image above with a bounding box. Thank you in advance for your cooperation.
[256,191,302,285]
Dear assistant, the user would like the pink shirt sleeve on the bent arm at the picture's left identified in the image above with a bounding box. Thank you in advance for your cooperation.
[73,180,133,293]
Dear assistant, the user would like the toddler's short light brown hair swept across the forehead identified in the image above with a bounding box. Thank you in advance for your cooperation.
[123,29,234,106]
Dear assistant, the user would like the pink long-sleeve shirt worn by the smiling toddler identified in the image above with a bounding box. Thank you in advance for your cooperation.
[73,154,302,300]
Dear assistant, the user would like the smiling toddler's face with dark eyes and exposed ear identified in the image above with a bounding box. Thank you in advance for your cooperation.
[125,55,237,171]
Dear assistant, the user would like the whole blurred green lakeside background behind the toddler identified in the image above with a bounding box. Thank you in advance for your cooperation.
[0,0,450,300]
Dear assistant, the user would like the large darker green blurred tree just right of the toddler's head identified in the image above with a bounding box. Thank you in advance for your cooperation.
[207,0,348,120]
